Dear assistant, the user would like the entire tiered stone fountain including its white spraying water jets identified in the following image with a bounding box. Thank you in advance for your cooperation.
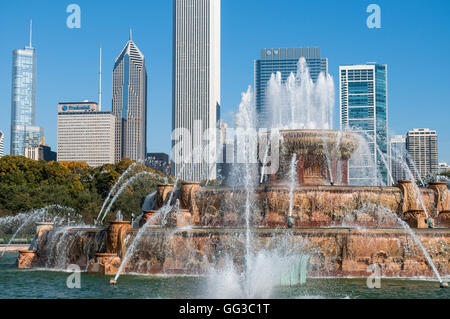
[14,59,450,297]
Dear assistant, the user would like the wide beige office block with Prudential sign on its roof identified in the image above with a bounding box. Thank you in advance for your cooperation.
[57,102,116,167]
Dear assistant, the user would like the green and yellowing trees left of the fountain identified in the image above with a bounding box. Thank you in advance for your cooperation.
[0,156,171,223]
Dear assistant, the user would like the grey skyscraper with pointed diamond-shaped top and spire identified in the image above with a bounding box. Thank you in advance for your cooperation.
[112,30,147,162]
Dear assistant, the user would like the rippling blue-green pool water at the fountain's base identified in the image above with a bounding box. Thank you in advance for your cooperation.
[0,254,450,299]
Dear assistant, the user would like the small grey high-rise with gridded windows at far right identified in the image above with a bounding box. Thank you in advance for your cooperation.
[406,128,439,179]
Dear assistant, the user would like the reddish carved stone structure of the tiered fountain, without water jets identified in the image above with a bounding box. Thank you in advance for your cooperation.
[19,130,450,277]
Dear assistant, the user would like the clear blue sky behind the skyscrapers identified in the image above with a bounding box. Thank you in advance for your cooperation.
[0,0,450,162]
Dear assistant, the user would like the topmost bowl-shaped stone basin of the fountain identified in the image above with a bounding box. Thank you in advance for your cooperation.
[276,130,359,185]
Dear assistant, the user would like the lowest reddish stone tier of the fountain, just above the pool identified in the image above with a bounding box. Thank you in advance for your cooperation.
[20,227,450,277]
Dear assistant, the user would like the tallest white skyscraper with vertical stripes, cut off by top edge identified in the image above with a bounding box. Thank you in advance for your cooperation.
[172,0,220,181]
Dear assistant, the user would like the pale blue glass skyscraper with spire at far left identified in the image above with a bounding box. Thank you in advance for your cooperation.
[11,24,44,156]
